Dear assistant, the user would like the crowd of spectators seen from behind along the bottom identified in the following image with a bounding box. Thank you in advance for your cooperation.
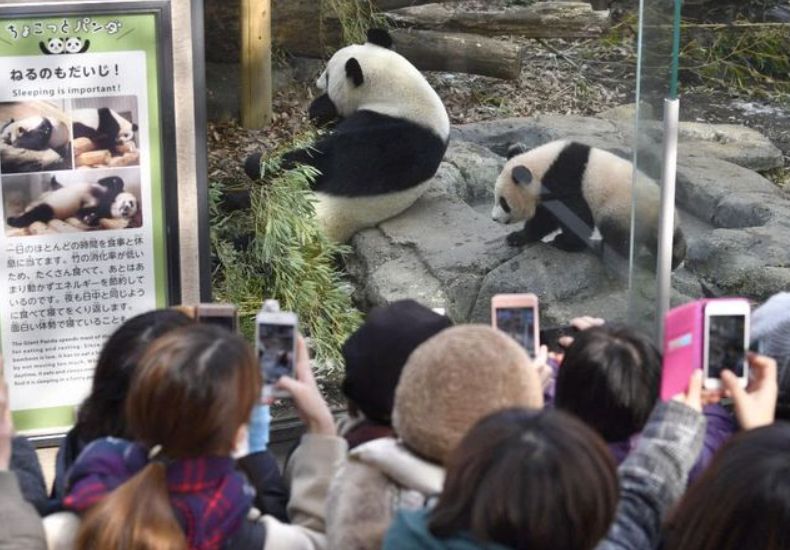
[0,293,790,550]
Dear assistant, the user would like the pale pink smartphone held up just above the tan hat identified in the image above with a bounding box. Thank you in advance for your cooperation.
[491,294,540,358]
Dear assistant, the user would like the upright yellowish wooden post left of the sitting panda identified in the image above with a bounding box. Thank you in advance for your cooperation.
[241,0,272,128]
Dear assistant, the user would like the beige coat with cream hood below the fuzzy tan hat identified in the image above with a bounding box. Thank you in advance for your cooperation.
[327,438,445,550]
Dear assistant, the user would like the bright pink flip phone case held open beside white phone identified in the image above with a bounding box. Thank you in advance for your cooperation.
[661,300,710,401]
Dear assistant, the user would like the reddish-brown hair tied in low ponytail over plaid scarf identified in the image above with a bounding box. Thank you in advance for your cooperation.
[75,325,262,550]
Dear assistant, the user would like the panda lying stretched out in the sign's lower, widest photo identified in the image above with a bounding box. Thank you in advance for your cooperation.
[6,176,138,227]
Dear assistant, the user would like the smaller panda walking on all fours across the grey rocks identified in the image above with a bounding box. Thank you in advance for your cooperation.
[491,141,686,269]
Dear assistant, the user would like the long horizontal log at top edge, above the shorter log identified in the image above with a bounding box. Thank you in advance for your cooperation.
[387,2,609,38]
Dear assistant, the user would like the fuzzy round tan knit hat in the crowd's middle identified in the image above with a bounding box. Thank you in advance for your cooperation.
[393,325,543,464]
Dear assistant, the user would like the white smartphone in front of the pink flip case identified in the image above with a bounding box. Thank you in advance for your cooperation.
[702,299,750,389]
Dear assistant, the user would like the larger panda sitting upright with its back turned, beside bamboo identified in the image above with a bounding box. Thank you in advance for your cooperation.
[245,29,450,242]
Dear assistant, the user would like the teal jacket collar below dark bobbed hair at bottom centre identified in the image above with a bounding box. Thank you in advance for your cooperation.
[382,510,509,550]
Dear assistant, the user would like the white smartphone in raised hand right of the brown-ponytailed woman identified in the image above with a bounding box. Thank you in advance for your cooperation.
[255,311,297,399]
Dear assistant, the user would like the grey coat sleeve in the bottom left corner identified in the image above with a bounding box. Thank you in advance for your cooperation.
[0,471,47,550]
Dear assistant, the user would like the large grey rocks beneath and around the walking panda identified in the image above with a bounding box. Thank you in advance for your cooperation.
[349,109,790,330]
